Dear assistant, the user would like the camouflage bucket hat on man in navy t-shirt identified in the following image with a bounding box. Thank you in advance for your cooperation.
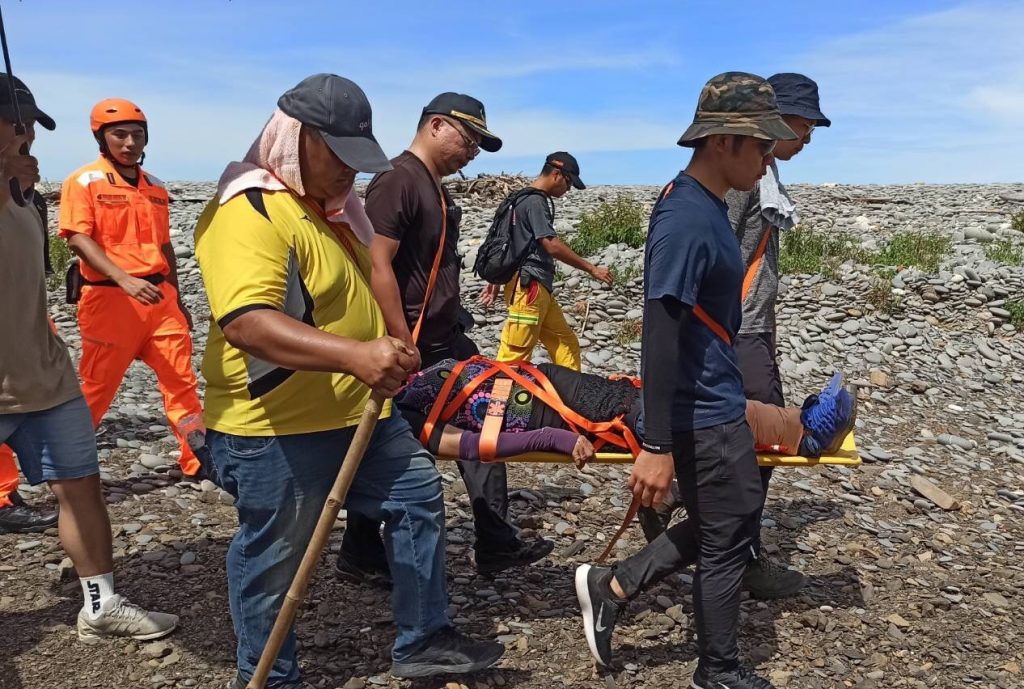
[679,72,797,146]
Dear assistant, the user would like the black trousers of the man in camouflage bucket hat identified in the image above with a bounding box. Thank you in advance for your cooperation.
[614,418,764,672]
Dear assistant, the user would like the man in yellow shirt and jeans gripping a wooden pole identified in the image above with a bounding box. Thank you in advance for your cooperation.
[196,74,504,689]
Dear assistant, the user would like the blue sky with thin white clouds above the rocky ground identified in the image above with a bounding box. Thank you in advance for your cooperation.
[4,0,1024,184]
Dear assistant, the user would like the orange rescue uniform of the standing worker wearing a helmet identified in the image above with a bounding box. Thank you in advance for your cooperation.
[59,157,203,476]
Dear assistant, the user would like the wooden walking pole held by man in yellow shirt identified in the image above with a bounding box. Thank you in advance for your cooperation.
[246,392,384,689]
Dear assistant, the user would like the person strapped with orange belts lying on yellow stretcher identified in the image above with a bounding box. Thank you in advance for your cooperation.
[394,356,856,468]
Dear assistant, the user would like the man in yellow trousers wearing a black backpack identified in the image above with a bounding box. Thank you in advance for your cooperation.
[477,150,612,371]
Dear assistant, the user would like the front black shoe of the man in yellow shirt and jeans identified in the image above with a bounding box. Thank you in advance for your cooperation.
[391,627,505,679]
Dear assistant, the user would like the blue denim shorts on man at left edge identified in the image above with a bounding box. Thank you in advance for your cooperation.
[0,395,99,485]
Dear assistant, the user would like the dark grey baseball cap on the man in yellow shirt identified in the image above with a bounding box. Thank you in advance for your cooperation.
[278,74,391,172]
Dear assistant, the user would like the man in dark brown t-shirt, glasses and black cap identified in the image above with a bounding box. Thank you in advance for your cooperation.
[337,93,554,584]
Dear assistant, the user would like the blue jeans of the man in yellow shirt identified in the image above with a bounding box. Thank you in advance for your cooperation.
[206,412,449,687]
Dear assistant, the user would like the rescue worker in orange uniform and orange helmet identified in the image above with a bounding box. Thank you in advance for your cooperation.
[59,98,205,476]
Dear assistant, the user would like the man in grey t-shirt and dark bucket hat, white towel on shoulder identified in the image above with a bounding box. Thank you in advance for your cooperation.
[725,74,831,598]
